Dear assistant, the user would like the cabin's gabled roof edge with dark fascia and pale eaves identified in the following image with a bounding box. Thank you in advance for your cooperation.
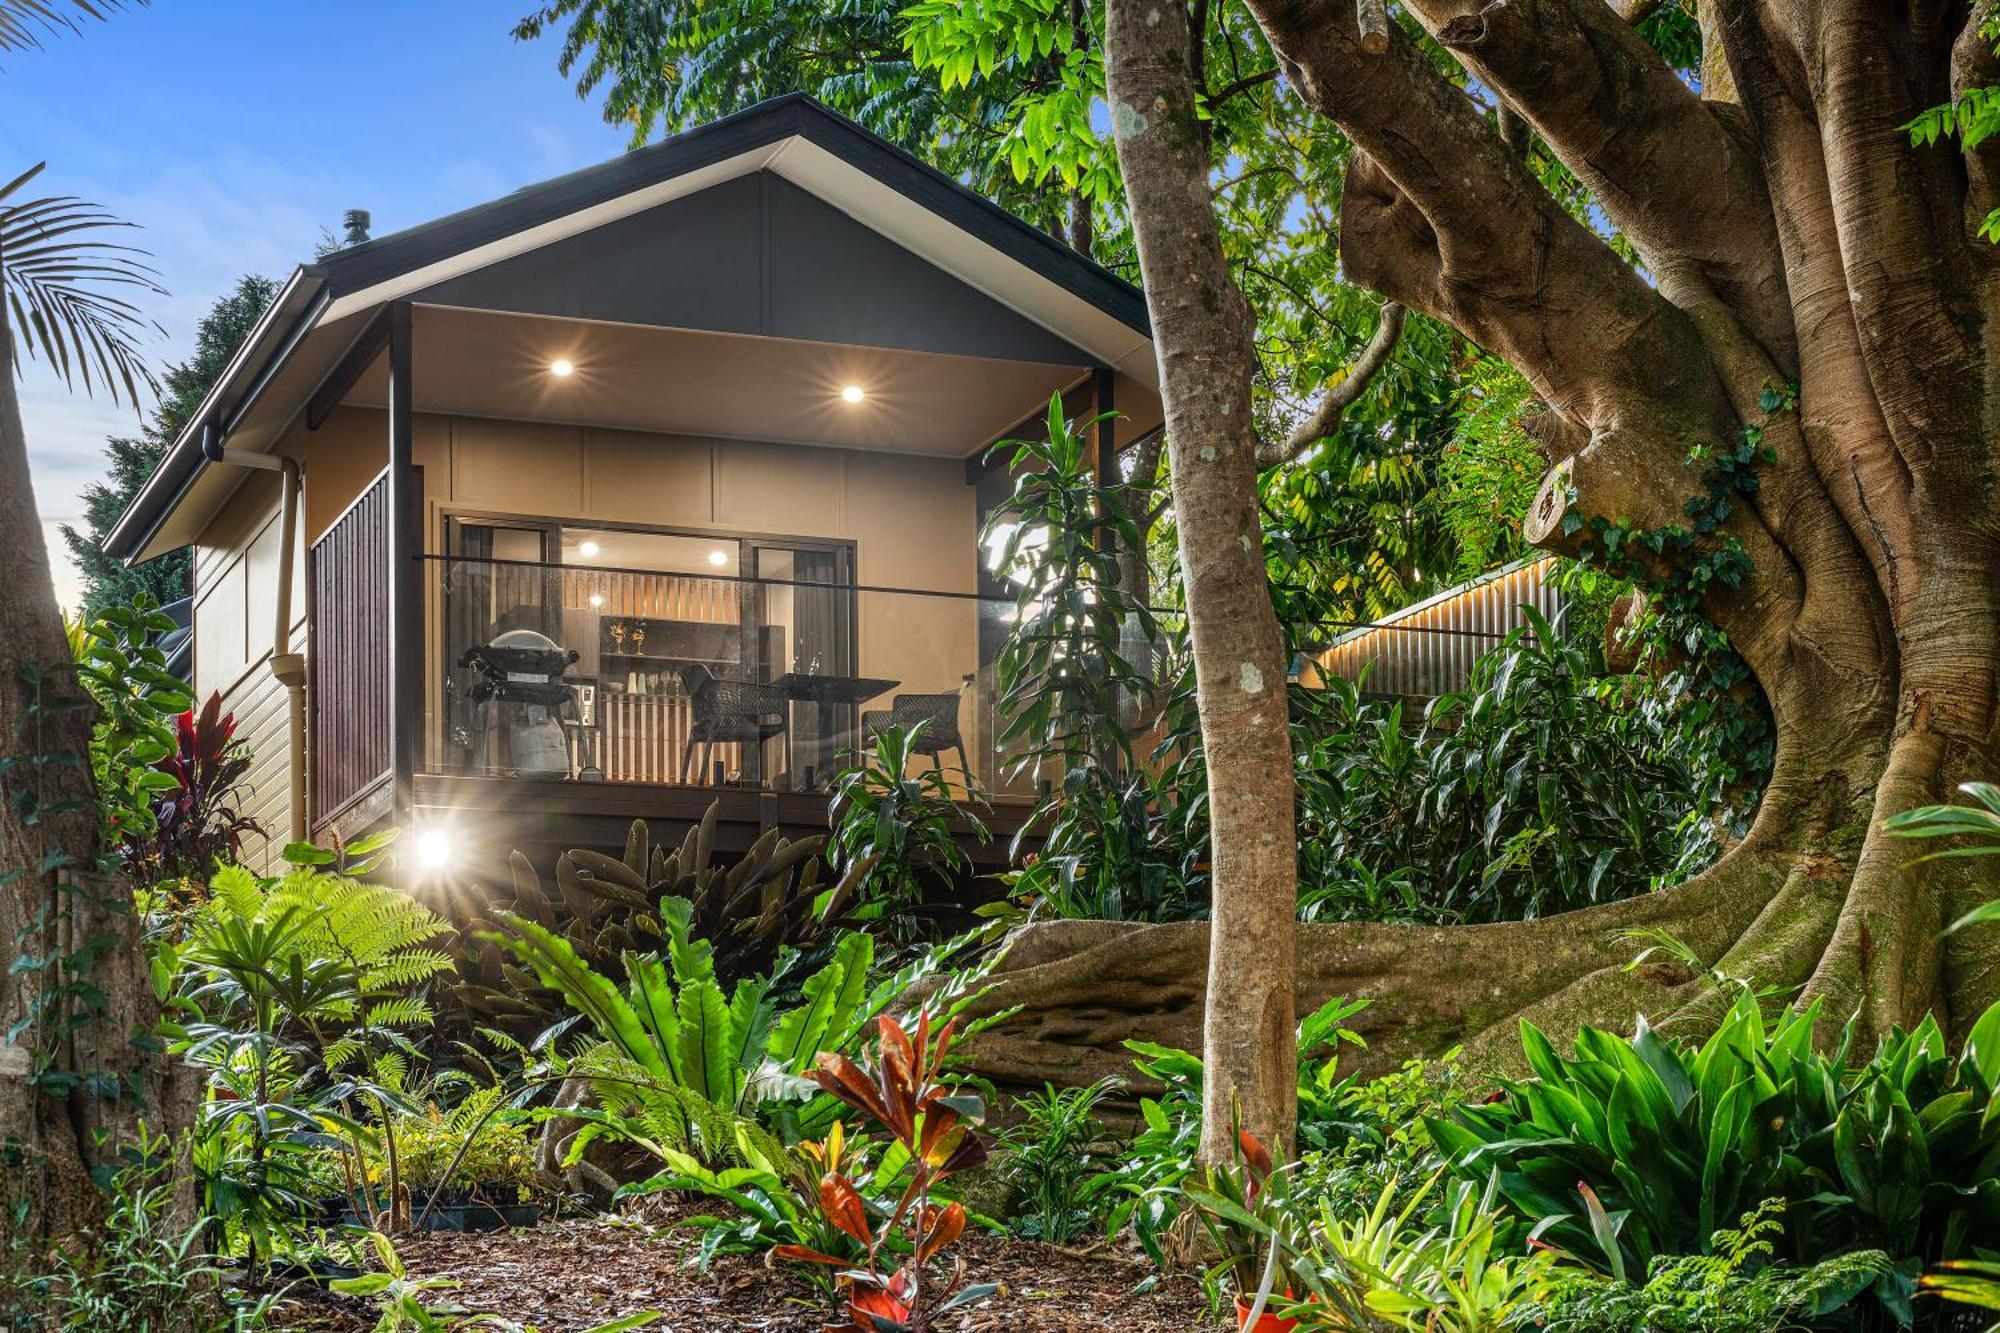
[106,94,1158,560]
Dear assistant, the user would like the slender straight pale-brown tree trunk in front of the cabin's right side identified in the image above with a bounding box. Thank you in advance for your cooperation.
[1104,0,1298,1161]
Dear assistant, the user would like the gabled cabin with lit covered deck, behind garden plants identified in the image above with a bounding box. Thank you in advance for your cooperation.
[108,96,1160,869]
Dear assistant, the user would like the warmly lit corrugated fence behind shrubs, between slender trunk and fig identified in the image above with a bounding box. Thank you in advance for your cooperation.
[1318,556,1562,699]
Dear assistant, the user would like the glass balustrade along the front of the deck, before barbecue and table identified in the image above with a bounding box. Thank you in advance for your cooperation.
[426,556,1104,797]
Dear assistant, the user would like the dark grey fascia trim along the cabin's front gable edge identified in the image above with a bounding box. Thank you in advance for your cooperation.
[320,92,1150,336]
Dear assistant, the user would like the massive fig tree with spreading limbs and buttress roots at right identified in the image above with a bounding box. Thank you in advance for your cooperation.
[960,0,2000,1079]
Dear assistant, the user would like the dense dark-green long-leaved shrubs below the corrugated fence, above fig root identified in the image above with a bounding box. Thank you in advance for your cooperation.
[1292,608,1726,921]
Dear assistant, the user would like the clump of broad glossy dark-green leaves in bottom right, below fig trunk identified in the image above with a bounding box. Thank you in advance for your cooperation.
[1430,995,2000,1323]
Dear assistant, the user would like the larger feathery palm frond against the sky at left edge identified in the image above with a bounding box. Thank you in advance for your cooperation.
[0,160,166,406]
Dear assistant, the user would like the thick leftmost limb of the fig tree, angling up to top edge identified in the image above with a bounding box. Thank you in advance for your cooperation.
[1250,0,1732,462]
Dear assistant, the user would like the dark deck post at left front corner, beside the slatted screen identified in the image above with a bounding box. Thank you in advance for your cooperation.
[388,300,424,825]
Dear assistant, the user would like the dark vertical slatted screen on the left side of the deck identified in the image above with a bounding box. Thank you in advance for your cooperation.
[310,470,394,829]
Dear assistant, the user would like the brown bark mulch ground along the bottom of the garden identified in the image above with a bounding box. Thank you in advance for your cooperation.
[258,1209,1224,1333]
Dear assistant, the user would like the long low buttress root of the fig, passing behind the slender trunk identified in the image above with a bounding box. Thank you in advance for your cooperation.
[964,843,1798,1087]
